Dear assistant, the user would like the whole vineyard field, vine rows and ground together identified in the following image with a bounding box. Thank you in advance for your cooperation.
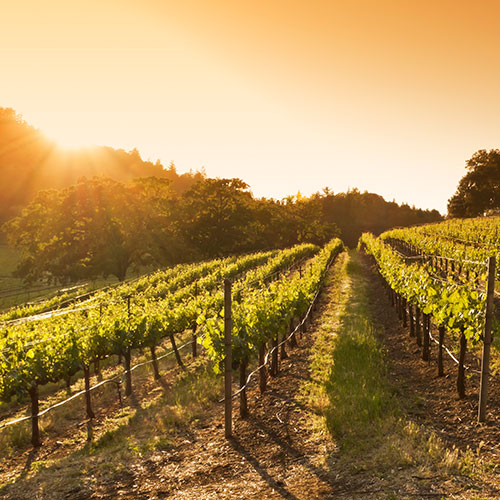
[0,225,500,500]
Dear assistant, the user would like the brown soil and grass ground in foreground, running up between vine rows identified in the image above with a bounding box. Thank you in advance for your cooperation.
[0,248,499,500]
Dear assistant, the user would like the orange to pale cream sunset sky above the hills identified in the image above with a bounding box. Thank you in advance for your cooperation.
[0,0,500,213]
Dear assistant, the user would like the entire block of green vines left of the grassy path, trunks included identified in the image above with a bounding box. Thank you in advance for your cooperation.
[0,240,341,446]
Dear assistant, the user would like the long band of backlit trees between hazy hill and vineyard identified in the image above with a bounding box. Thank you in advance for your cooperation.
[3,177,440,283]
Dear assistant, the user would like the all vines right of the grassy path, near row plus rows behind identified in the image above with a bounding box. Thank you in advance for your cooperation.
[360,224,498,420]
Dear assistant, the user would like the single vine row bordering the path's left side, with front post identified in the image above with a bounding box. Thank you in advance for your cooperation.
[203,239,344,437]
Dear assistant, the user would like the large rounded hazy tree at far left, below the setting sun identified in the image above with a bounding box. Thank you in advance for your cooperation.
[3,178,148,282]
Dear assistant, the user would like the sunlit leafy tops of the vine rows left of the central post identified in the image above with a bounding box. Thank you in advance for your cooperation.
[0,244,318,401]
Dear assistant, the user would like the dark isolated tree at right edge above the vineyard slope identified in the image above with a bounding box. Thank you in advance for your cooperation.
[448,149,500,217]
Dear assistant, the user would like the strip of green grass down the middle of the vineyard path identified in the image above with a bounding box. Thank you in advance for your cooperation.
[326,254,397,451]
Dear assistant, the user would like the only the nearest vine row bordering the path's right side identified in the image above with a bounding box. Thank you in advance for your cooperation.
[360,233,495,421]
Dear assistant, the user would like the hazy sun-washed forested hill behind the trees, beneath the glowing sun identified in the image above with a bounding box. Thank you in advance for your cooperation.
[0,108,204,224]
